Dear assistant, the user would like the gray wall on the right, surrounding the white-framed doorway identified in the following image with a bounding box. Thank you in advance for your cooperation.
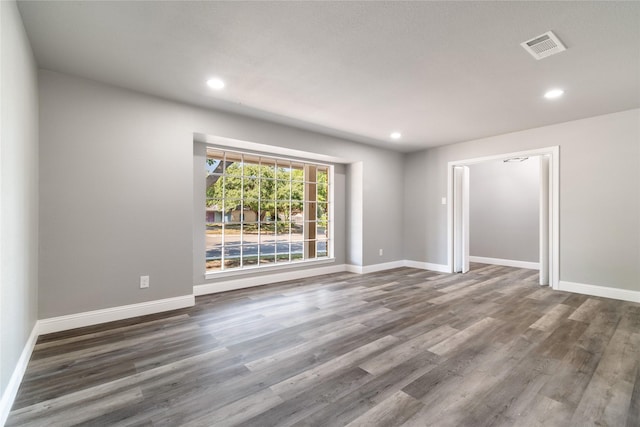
[404,109,640,290]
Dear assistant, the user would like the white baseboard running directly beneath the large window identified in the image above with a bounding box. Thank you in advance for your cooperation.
[193,264,347,296]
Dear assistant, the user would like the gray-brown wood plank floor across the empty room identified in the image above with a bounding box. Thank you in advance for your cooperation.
[7,264,640,427]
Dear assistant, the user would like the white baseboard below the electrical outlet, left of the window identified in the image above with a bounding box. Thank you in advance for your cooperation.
[38,295,195,334]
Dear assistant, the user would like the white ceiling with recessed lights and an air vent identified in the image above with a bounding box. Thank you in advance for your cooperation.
[18,1,640,151]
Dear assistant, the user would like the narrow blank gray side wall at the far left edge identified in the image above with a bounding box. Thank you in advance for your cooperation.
[0,1,38,404]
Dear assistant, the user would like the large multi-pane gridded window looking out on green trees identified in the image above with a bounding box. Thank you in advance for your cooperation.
[206,148,332,273]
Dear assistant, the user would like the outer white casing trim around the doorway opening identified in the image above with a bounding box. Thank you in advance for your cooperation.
[447,146,560,289]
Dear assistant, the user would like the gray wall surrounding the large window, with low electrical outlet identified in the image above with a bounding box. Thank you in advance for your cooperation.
[39,70,403,318]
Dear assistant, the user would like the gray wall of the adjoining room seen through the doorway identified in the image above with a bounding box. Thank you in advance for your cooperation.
[469,156,540,262]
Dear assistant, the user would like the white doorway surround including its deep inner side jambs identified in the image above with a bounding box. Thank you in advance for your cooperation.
[447,147,559,289]
